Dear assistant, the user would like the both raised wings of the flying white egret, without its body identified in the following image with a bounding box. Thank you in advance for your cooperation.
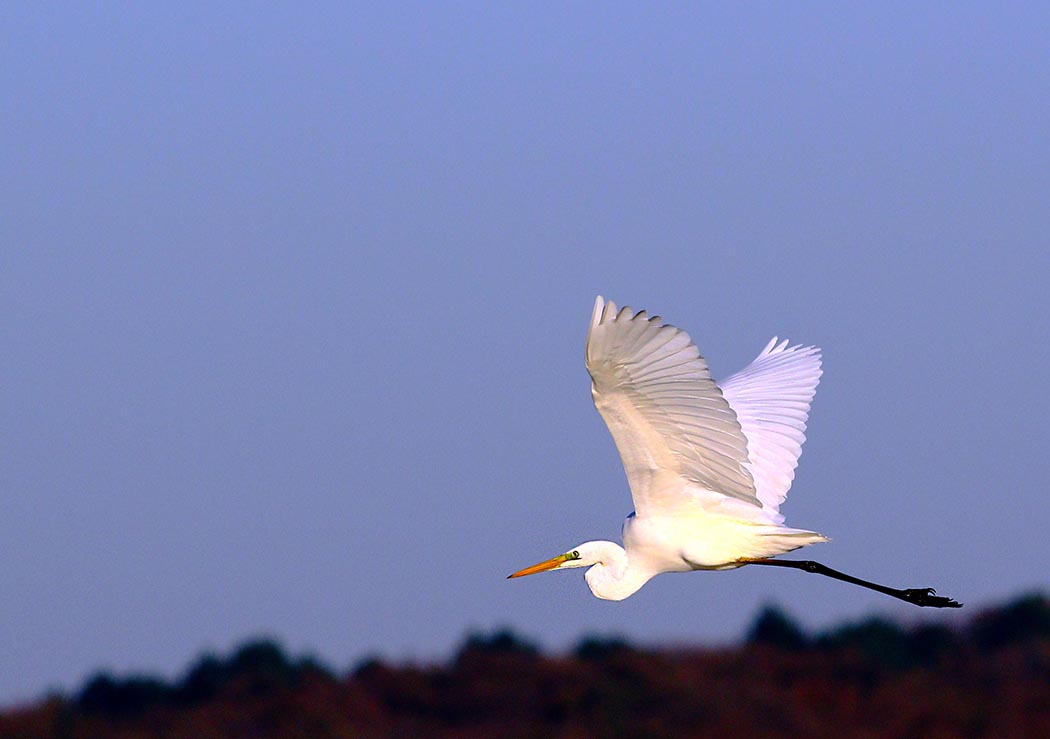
[586,296,821,524]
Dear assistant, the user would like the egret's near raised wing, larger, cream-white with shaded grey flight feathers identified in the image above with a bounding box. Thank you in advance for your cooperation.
[587,295,761,513]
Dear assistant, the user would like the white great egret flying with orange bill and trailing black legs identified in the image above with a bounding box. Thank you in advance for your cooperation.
[509,295,961,608]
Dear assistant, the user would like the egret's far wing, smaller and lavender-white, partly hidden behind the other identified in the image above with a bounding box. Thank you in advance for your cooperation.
[721,337,821,523]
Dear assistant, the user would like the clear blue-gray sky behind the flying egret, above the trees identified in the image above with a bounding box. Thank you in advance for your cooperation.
[0,3,1050,704]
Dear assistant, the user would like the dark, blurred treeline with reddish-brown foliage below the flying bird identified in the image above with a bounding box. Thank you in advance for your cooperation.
[0,595,1050,739]
